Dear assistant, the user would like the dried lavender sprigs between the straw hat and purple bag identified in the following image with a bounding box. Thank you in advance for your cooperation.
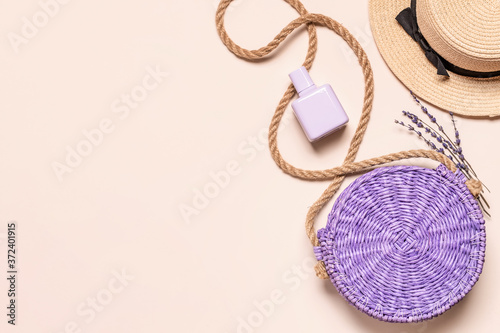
[395,92,490,216]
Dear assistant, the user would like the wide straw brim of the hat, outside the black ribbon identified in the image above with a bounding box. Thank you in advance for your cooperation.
[369,0,500,117]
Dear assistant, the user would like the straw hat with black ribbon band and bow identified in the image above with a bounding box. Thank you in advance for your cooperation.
[369,0,500,116]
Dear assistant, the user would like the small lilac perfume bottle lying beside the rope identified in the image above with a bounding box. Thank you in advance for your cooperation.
[289,66,349,142]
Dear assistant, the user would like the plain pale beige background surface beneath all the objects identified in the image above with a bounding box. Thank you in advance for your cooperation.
[0,0,500,333]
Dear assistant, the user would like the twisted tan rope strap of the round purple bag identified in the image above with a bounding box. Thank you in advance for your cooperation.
[215,0,481,256]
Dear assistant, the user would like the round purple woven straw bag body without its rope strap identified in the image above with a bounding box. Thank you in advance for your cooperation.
[314,165,486,322]
